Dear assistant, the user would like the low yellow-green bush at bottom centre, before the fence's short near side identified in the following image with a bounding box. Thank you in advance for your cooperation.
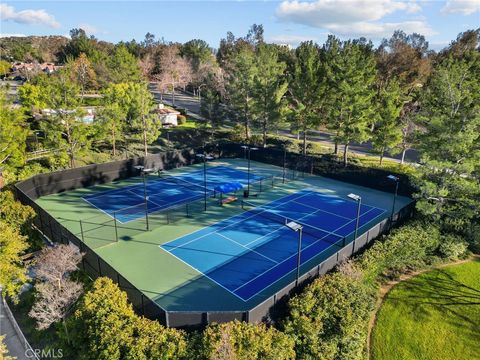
[198,320,295,360]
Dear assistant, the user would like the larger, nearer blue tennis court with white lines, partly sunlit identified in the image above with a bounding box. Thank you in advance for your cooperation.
[161,190,385,301]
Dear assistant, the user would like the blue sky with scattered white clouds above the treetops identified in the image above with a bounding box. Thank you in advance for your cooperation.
[0,0,480,50]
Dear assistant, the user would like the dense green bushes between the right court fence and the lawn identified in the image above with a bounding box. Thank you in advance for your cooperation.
[283,221,466,359]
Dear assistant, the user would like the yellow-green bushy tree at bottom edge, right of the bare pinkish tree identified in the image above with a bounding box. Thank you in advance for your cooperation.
[69,278,187,360]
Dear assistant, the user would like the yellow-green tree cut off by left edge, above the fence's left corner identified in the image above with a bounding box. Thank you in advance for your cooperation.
[0,86,28,167]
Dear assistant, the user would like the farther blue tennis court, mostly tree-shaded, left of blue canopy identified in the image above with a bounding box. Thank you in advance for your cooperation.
[83,166,263,223]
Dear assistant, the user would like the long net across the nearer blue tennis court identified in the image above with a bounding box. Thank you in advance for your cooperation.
[242,200,345,247]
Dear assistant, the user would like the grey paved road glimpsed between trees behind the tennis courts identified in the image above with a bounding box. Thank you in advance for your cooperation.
[149,83,419,163]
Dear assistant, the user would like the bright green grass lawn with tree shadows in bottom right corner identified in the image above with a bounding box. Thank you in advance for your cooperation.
[372,259,480,360]
